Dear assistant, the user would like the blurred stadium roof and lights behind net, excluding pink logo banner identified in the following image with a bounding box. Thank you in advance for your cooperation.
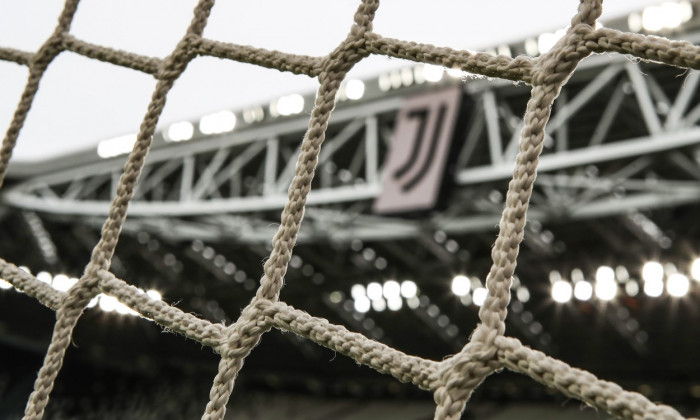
[0,1,700,420]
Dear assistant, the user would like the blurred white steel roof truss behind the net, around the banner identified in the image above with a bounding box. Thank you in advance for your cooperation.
[2,53,700,242]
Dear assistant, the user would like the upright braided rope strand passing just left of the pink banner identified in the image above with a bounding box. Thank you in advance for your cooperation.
[202,4,379,420]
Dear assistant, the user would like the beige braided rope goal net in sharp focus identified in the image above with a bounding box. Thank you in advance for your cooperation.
[0,0,700,420]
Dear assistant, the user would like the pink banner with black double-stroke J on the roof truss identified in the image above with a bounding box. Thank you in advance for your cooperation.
[374,86,462,214]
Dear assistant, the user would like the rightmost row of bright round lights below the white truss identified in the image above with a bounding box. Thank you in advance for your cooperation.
[549,259,700,303]
